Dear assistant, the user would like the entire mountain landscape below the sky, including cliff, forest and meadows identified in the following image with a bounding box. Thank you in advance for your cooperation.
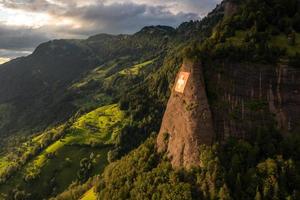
[0,0,300,199]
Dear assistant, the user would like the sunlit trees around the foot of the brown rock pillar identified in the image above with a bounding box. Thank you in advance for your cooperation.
[97,130,300,200]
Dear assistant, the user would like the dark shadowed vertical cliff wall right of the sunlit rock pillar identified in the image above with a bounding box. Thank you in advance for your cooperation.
[205,63,300,141]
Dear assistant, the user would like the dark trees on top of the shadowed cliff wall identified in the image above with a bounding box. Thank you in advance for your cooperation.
[189,0,300,63]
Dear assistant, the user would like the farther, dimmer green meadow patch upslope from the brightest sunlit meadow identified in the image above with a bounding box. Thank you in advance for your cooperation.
[69,58,156,110]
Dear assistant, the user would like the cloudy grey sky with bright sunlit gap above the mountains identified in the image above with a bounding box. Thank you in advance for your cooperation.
[0,0,221,63]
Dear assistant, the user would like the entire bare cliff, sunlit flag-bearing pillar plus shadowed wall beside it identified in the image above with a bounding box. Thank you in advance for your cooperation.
[157,61,300,168]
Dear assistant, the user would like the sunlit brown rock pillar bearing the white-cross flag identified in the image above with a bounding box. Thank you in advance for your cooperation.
[157,61,214,168]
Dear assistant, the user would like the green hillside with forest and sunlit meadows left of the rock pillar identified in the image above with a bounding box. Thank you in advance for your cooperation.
[0,26,175,199]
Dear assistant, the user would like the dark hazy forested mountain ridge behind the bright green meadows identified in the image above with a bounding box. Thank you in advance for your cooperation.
[0,27,174,138]
